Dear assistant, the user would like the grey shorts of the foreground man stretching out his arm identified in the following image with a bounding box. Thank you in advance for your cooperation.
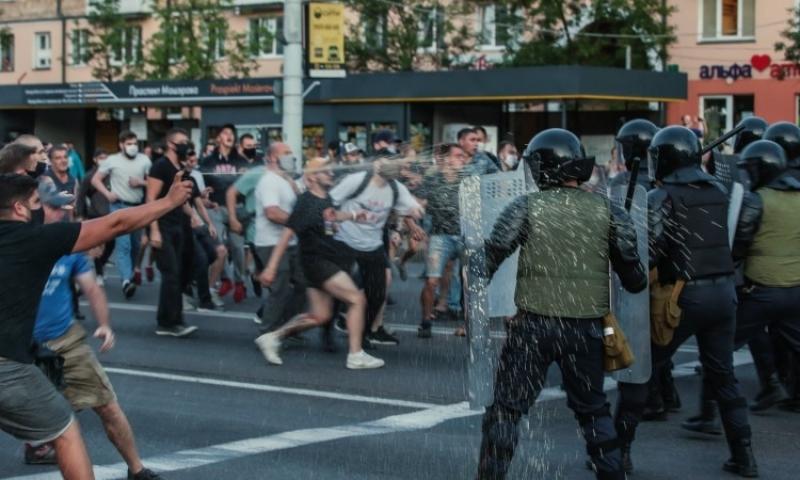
[0,357,74,446]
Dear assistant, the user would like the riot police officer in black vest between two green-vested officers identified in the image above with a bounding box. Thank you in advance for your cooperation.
[618,126,758,477]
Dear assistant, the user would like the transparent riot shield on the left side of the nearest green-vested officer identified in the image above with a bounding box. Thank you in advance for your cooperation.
[459,168,535,409]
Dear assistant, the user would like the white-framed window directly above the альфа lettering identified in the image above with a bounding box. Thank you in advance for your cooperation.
[700,0,756,40]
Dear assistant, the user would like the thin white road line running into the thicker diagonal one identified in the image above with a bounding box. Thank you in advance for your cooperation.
[105,367,441,409]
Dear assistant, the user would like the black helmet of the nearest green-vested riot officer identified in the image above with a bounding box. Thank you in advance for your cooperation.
[523,128,594,185]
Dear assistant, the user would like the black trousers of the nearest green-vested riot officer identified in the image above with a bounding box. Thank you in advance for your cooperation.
[477,313,625,480]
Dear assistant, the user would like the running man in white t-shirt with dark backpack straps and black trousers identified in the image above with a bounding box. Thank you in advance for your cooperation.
[330,151,422,345]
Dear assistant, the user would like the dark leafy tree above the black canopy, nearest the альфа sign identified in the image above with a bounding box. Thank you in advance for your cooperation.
[497,0,675,69]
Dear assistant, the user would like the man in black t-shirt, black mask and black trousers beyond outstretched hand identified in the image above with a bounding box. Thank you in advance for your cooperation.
[147,128,198,337]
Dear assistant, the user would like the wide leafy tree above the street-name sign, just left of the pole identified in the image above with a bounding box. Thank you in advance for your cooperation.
[140,0,272,80]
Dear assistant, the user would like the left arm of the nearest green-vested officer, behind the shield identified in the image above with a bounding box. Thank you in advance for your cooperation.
[484,195,530,278]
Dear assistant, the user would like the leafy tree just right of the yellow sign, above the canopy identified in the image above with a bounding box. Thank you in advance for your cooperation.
[344,0,474,71]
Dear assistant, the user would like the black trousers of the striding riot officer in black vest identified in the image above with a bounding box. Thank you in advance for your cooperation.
[616,277,751,441]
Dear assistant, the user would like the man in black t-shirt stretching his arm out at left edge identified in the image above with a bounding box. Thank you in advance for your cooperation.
[0,170,191,479]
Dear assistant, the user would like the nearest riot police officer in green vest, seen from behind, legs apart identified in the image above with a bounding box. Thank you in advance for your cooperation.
[477,129,647,480]
